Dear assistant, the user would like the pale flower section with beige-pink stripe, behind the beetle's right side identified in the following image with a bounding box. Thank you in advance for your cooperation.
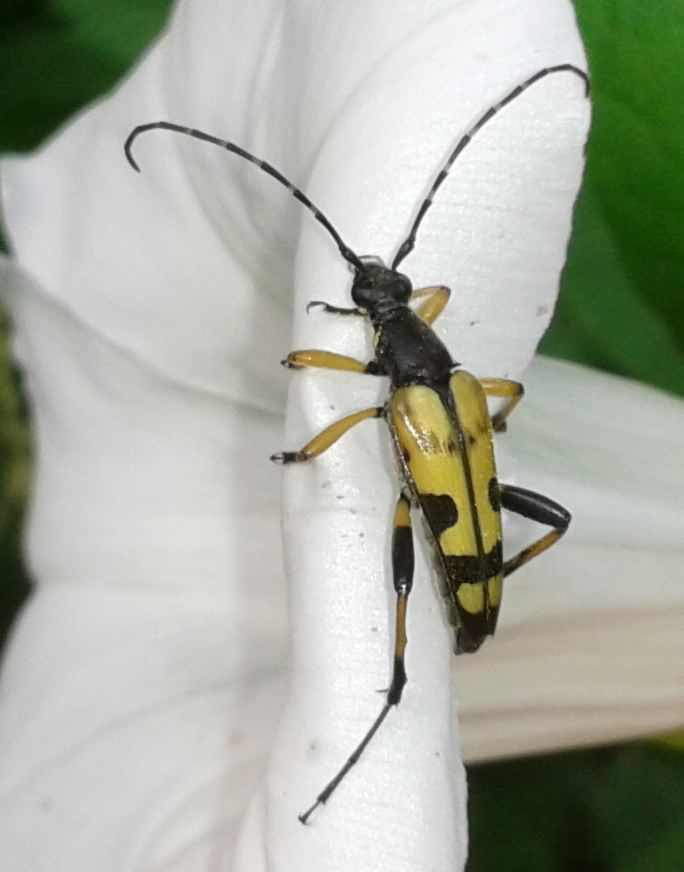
[455,359,684,760]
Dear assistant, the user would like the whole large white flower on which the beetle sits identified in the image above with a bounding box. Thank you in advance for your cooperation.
[0,0,684,872]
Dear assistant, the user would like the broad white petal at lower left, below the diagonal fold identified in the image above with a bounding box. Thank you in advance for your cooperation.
[0,258,286,872]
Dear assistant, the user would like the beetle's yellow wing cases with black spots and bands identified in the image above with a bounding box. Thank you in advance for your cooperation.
[388,370,503,651]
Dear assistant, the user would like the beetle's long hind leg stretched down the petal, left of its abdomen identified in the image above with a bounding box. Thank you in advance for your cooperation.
[299,494,414,824]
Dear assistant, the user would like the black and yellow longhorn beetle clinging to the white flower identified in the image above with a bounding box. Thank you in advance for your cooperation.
[125,64,589,823]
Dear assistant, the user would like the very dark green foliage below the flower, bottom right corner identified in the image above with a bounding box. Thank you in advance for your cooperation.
[467,745,684,872]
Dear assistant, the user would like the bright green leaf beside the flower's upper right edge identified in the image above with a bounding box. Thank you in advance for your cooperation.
[542,0,684,394]
